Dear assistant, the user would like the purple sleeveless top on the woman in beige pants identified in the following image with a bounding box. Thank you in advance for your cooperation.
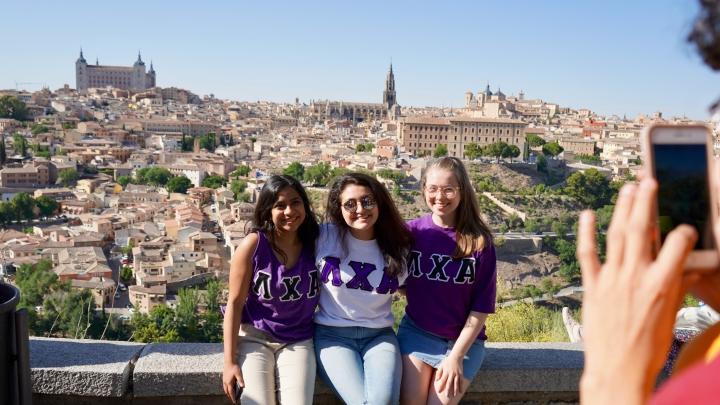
[242,232,320,343]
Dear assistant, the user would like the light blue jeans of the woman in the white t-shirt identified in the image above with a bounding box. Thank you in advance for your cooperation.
[315,325,402,405]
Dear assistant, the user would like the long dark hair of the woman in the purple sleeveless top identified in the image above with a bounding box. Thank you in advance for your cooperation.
[250,175,320,262]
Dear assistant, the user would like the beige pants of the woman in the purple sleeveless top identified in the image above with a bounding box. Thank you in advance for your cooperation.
[237,324,315,405]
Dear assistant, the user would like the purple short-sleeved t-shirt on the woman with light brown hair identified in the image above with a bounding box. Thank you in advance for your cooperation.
[405,215,497,340]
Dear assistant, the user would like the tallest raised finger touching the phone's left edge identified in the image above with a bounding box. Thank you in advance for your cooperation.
[623,178,657,269]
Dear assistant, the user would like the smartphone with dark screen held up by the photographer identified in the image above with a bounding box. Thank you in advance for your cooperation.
[643,121,720,270]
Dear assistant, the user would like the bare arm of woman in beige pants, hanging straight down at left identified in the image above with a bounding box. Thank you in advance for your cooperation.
[223,233,258,402]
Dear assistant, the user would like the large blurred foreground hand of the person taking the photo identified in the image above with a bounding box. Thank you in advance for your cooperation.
[577,178,697,404]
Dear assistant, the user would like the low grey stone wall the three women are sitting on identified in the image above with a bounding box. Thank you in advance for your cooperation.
[30,338,583,405]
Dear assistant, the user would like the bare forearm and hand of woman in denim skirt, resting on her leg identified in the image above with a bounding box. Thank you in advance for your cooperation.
[435,311,488,397]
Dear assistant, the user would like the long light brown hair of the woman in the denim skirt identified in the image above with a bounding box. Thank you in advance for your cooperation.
[420,156,492,259]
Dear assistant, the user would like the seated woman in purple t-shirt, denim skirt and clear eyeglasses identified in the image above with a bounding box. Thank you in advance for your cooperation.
[398,157,497,405]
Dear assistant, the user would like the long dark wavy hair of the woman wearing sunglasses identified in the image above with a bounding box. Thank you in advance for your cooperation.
[325,173,413,276]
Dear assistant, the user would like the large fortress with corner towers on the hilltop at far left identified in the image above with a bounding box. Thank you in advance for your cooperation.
[75,49,156,92]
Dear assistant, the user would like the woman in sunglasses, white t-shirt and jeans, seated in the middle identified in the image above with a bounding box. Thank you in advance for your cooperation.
[315,173,412,404]
